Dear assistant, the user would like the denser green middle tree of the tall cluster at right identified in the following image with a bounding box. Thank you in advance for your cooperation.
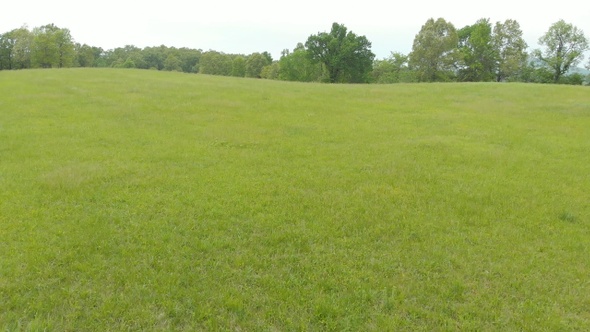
[457,19,496,82]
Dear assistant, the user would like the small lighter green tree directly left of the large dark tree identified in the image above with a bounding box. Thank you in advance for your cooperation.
[278,43,323,82]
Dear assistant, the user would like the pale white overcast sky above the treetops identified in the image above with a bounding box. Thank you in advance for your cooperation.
[0,0,590,60]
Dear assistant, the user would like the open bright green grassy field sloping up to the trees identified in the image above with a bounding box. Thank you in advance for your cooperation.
[0,69,590,331]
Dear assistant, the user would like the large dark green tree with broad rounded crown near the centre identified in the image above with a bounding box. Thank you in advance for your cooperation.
[305,23,375,83]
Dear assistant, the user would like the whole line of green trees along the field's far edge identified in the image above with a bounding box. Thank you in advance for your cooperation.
[0,18,590,84]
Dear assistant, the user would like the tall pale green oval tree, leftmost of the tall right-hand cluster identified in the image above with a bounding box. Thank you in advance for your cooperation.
[410,18,459,82]
